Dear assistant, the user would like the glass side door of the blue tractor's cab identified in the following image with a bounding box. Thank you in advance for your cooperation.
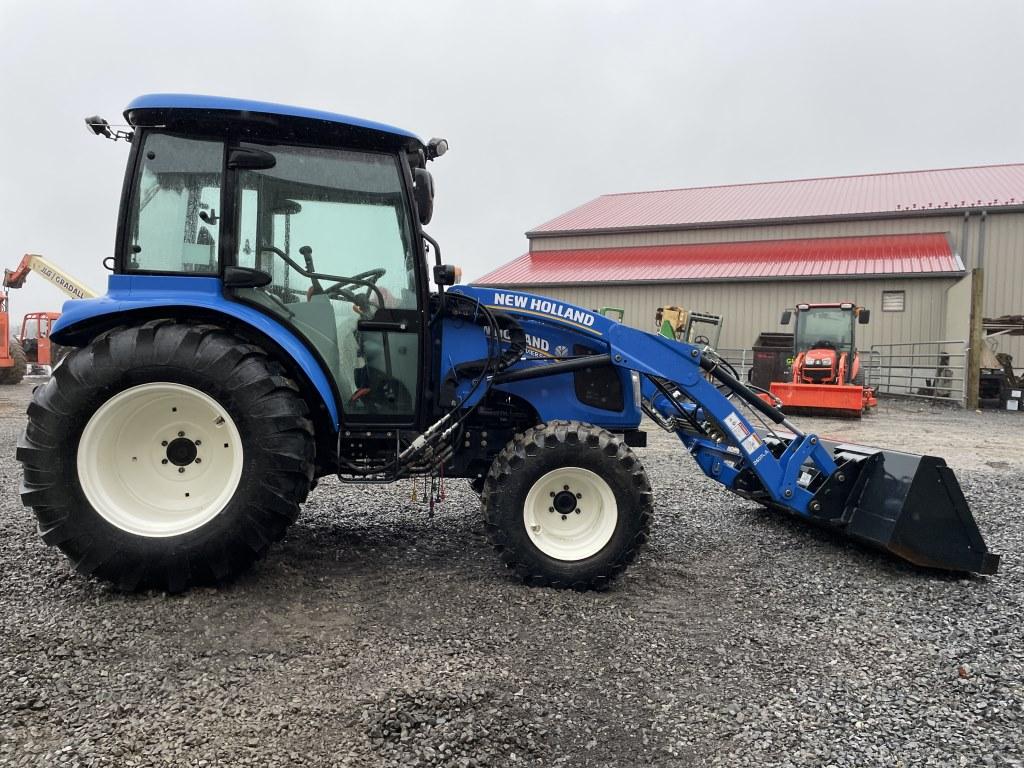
[227,143,423,424]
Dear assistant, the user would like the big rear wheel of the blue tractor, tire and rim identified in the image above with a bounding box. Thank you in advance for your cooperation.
[17,321,314,592]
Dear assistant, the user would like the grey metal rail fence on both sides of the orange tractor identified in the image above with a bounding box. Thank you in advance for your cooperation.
[718,340,967,406]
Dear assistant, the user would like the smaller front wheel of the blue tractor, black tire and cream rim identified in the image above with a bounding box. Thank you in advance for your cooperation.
[482,421,653,590]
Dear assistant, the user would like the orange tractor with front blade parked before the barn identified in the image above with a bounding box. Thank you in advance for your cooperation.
[764,301,878,418]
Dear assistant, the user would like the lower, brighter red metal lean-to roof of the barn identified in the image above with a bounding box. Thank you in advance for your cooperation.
[473,232,964,286]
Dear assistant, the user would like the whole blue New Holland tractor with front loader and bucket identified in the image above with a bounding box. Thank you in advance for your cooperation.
[17,94,998,591]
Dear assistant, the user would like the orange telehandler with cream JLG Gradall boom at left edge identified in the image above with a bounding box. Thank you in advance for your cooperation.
[0,253,97,384]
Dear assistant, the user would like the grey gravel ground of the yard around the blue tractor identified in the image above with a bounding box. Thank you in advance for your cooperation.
[0,382,1024,766]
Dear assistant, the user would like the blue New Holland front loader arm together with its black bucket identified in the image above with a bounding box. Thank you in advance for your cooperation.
[453,287,998,573]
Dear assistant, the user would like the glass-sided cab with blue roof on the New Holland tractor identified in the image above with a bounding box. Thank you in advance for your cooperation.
[87,95,446,425]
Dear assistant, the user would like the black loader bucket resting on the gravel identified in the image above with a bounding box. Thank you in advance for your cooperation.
[810,445,999,573]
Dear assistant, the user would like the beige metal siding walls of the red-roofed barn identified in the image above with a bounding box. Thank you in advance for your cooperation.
[527,211,1024,369]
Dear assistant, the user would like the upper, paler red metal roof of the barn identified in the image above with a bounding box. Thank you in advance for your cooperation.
[526,164,1024,237]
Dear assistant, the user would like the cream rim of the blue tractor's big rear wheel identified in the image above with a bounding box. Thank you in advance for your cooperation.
[78,382,242,538]
